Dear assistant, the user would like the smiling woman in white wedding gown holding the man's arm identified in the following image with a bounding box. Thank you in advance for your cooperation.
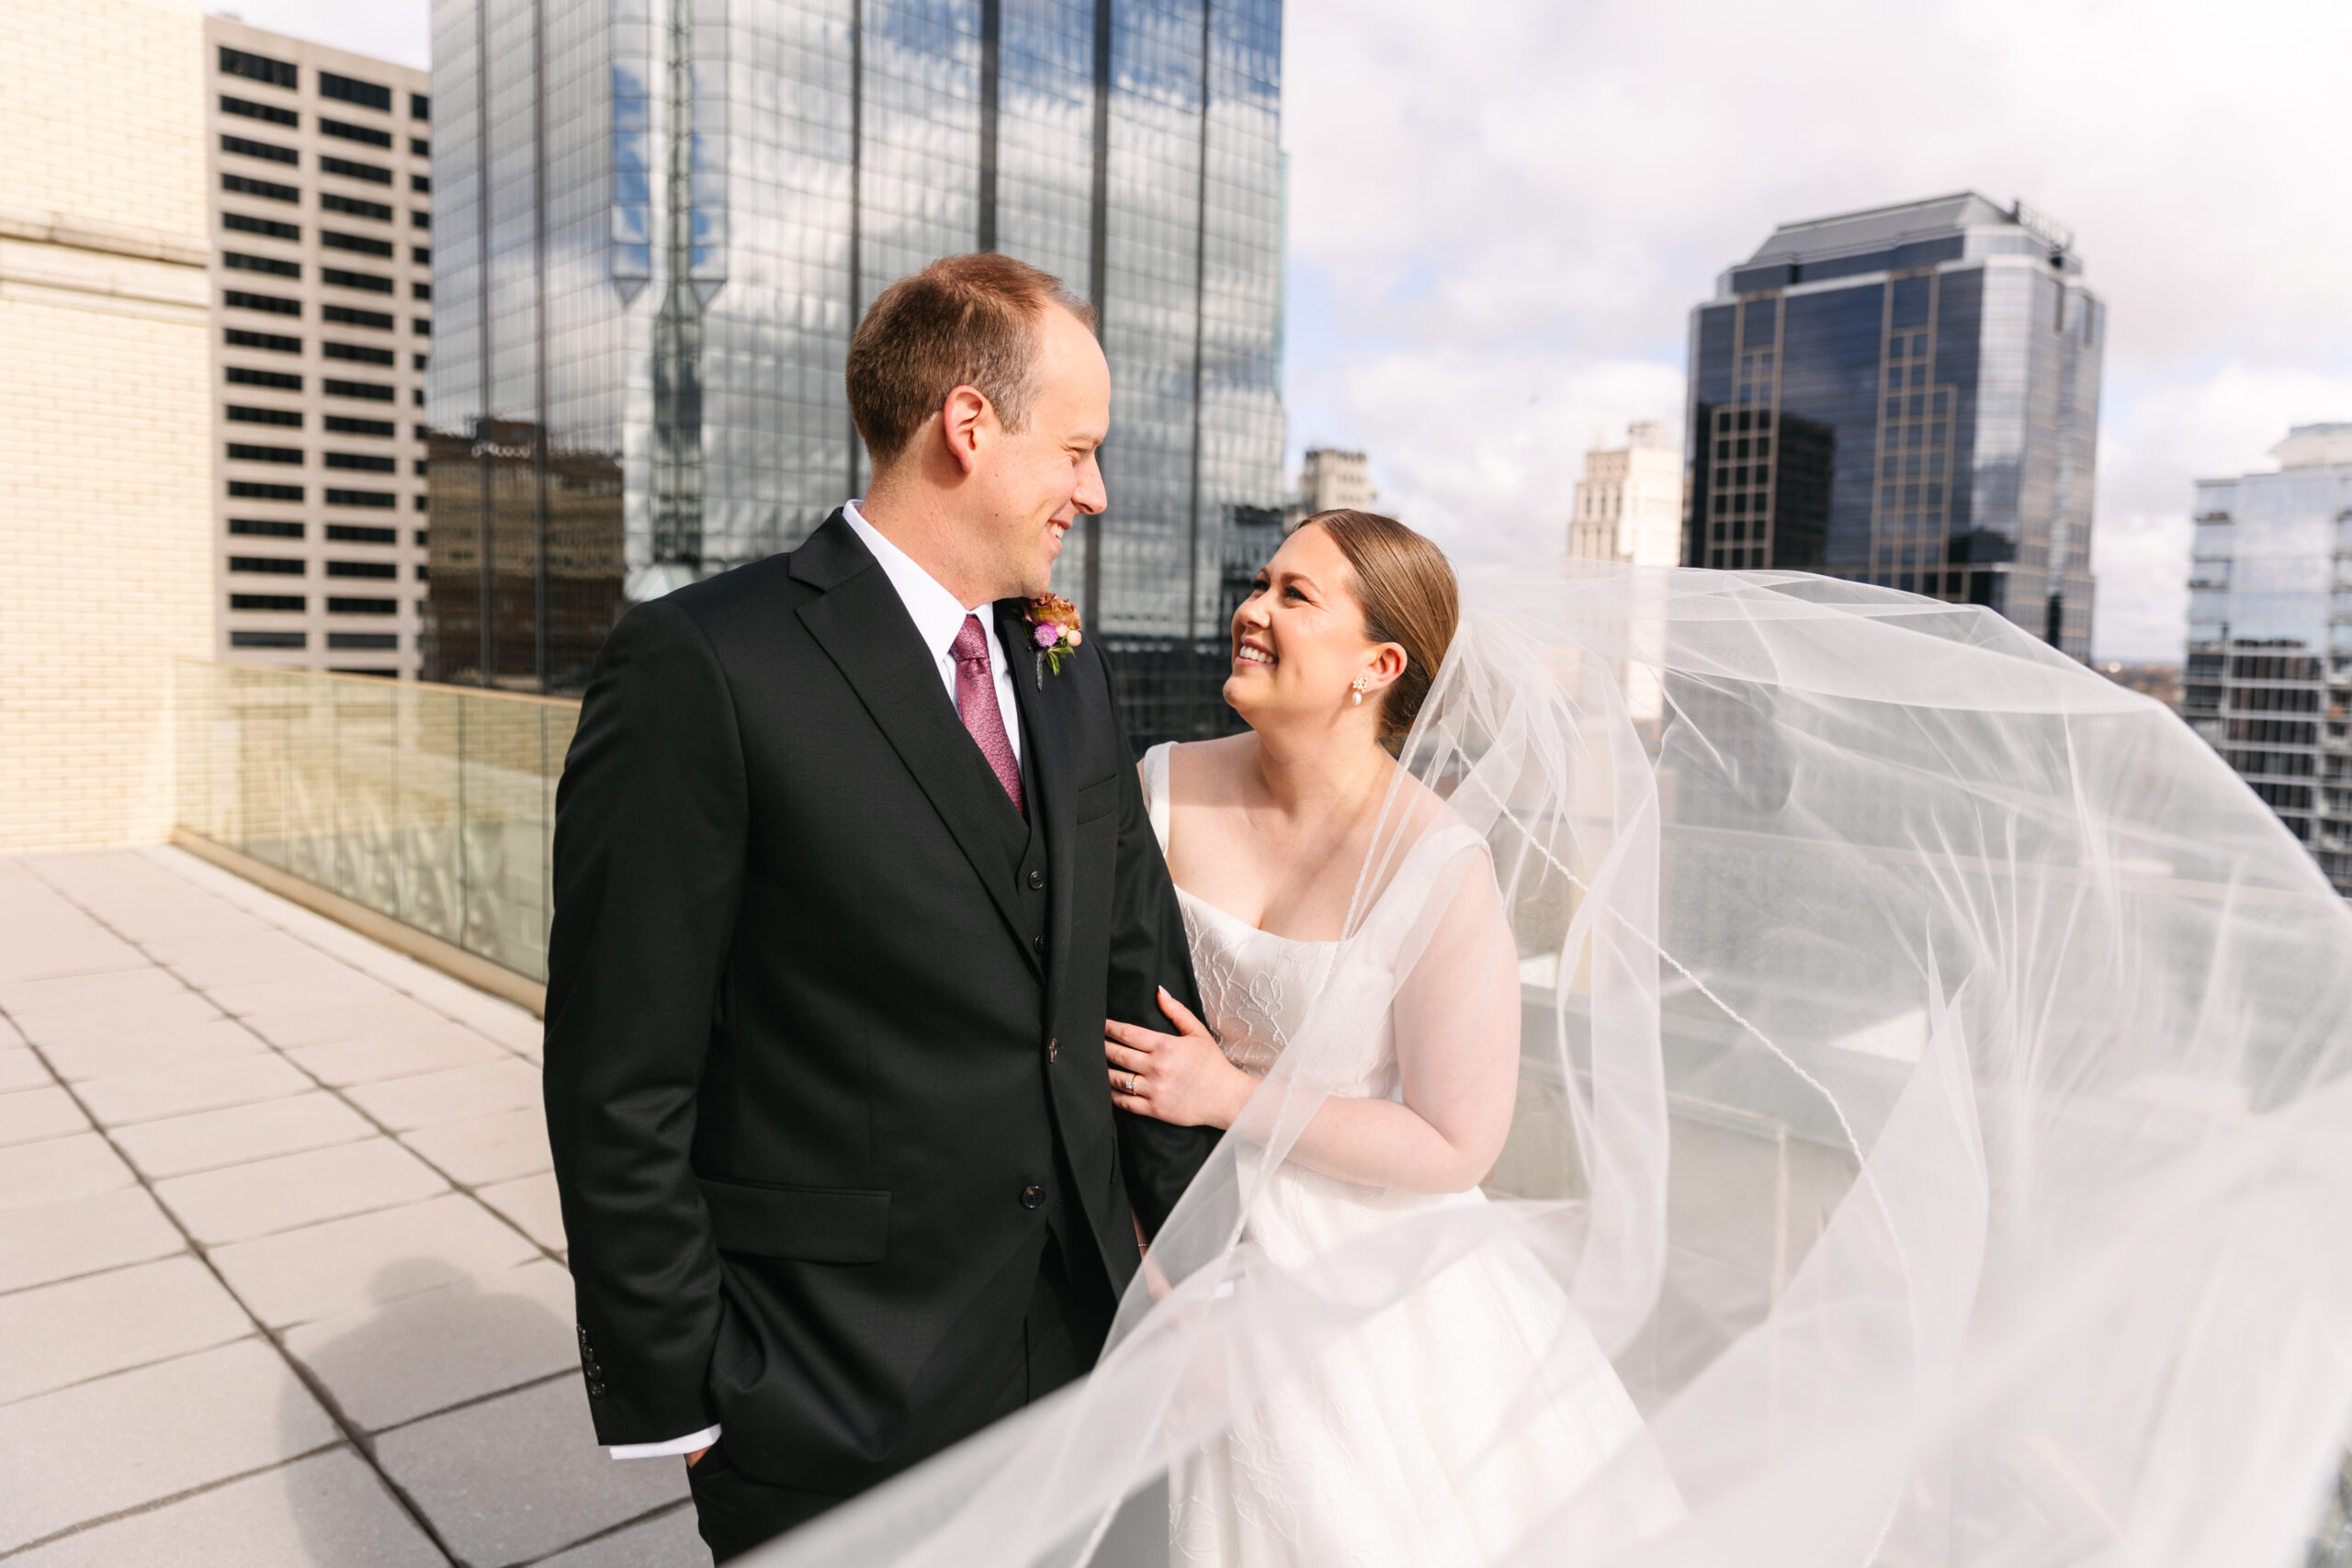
[1105,510,1677,1568]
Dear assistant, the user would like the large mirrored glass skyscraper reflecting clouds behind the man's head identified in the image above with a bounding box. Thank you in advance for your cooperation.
[425,0,1282,739]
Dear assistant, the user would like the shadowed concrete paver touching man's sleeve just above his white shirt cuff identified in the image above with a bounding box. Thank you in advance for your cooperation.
[287,1258,581,1432]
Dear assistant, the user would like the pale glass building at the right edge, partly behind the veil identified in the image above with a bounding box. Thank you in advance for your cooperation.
[2180,425,2352,898]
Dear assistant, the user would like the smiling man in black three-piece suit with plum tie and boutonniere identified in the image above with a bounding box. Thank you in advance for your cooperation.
[546,254,1214,1561]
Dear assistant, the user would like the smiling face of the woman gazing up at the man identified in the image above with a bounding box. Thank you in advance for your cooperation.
[1226,526,1404,733]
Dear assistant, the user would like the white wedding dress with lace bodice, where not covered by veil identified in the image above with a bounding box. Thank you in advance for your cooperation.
[1143,745,1681,1568]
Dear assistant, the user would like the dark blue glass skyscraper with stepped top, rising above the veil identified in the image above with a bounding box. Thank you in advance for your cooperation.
[1684,193,2105,659]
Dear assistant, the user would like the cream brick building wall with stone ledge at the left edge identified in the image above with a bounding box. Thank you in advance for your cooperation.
[0,0,214,853]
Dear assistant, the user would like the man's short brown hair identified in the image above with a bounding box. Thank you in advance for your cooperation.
[844,252,1093,466]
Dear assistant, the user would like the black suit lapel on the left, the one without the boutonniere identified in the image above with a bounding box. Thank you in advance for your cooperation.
[793,513,1040,966]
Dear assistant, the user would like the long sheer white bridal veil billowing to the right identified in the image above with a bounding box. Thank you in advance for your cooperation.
[760,562,2352,1568]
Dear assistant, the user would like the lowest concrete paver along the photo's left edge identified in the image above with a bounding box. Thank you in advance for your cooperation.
[0,1340,341,1551]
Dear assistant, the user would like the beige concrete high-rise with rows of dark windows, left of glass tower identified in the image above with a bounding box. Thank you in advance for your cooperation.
[202,17,433,677]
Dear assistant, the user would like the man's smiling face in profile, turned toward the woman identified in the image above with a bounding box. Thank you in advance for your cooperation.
[957,306,1110,600]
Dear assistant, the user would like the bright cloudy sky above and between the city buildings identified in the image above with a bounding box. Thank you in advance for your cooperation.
[257,0,2352,659]
